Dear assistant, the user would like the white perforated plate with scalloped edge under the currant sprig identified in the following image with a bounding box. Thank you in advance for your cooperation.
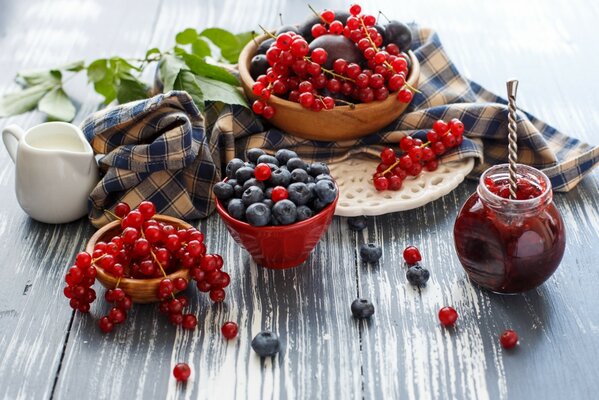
[329,157,474,217]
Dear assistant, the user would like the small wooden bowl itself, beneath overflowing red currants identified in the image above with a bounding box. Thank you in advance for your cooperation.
[85,214,191,303]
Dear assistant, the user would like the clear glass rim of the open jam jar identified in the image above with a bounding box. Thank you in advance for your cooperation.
[478,164,552,210]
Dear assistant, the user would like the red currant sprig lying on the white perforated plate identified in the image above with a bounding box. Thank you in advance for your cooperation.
[372,118,464,191]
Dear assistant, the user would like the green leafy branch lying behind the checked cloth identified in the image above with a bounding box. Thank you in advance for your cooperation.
[0,28,253,121]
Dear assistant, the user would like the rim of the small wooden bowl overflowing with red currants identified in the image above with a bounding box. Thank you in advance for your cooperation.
[85,214,193,287]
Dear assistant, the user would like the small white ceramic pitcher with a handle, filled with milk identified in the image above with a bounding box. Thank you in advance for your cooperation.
[2,122,98,224]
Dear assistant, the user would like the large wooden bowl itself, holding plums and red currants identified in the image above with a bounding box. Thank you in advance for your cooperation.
[239,35,420,141]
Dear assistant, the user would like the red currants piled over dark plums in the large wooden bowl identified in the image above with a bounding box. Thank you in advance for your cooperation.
[252,4,412,118]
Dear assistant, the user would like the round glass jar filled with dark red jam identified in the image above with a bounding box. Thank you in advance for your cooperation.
[453,164,566,293]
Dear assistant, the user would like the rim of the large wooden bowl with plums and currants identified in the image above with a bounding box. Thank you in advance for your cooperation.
[237,34,420,113]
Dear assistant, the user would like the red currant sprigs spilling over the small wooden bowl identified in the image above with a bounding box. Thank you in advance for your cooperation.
[64,201,230,333]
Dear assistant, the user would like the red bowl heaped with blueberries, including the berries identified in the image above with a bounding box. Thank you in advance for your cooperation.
[213,148,339,269]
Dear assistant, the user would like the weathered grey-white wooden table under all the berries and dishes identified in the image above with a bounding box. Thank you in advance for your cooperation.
[0,0,599,399]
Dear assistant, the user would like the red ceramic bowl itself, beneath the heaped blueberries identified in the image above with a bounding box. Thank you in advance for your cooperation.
[216,192,339,269]
